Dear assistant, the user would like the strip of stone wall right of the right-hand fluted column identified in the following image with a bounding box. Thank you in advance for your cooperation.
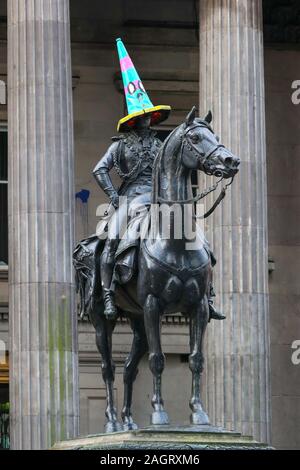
[265,49,300,449]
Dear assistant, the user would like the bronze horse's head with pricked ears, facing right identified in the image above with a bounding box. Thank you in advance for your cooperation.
[182,107,241,178]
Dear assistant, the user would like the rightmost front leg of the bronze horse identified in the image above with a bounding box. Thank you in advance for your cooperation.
[189,296,209,425]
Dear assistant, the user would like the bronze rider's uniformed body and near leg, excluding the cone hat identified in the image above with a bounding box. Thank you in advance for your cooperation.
[93,115,161,317]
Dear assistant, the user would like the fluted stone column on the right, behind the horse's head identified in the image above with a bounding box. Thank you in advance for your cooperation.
[200,0,270,441]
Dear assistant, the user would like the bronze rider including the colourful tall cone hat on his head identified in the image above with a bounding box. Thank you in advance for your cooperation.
[93,39,225,320]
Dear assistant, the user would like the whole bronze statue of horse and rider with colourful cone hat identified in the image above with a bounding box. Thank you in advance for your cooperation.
[73,39,240,432]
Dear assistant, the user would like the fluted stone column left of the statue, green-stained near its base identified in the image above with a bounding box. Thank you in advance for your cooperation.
[7,0,79,449]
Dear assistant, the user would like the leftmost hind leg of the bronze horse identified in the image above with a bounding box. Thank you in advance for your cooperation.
[95,315,122,433]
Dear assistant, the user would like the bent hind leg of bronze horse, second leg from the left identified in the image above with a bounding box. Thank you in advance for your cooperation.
[122,318,148,431]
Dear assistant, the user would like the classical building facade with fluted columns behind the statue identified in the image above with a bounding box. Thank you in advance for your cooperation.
[0,0,300,449]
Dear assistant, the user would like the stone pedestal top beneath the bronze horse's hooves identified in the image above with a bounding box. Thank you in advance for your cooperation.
[53,426,274,452]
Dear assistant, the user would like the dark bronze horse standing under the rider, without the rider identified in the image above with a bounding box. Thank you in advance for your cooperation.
[74,108,240,432]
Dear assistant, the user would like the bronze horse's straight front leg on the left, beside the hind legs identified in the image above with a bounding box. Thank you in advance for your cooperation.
[144,295,169,425]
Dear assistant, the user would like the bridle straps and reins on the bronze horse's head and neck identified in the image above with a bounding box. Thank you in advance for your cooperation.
[157,121,234,219]
